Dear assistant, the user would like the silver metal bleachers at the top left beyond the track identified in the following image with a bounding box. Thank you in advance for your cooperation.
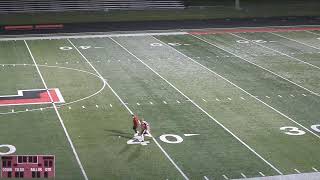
[0,0,185,13]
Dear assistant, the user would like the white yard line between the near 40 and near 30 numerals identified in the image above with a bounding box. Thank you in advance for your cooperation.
[110,38,282,175]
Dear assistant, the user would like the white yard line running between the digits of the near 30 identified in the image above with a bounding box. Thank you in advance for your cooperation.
[154,37,320,138]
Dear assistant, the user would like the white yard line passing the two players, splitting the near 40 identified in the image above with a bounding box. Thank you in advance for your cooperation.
[68,39,189,180]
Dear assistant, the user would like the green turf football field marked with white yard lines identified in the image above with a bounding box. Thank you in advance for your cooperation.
[0,27,320,180]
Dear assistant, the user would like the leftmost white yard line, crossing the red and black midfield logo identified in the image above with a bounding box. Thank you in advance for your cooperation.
[24,40,88,180]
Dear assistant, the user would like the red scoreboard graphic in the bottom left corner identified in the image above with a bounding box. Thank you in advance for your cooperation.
[0,155,55,179]
